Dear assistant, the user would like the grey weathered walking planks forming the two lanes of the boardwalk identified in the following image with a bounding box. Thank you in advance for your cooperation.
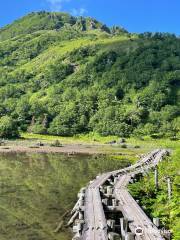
[71,149,167,240]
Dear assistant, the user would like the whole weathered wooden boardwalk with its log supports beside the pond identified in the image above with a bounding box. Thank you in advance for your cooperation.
[69,150,168,240]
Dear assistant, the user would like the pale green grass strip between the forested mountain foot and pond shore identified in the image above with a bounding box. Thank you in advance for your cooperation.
[21,133,180,163]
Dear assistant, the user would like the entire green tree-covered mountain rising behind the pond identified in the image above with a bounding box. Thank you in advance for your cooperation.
[0,12,180,138]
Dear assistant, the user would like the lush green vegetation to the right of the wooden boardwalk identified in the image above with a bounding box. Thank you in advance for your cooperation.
[129,139,180,240]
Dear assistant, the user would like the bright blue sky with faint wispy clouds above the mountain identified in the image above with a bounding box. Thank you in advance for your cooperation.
[0,0,180,35]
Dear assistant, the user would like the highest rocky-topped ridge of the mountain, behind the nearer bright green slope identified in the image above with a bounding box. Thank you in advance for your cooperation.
[0,11,127,41]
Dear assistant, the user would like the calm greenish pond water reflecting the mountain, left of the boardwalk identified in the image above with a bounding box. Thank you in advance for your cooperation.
[0,154,128,240]
